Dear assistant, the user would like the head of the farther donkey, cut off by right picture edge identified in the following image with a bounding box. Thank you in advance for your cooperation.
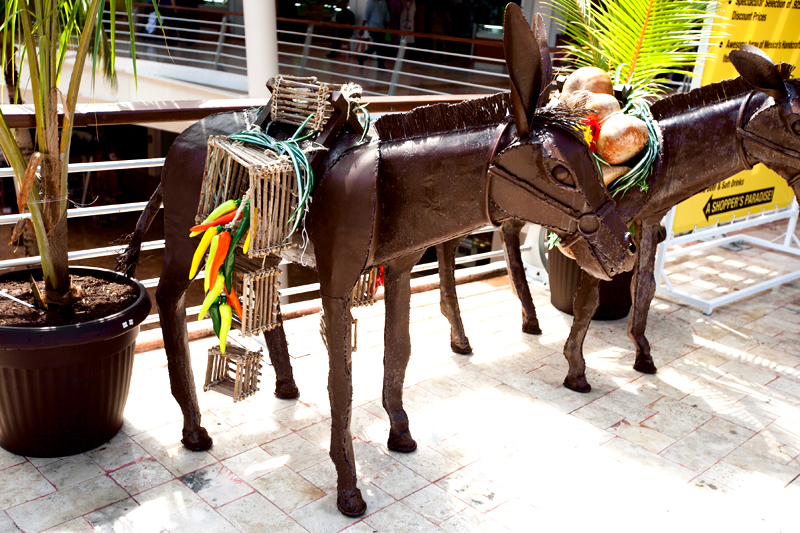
[730,45,800,185]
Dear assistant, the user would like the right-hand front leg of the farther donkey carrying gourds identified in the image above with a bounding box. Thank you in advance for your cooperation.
[628,222,661,374]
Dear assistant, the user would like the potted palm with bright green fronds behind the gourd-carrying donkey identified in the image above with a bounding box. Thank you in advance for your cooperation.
[548,0,715,320]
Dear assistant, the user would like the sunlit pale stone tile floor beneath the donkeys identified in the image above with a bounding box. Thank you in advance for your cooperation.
[0,232,800,533]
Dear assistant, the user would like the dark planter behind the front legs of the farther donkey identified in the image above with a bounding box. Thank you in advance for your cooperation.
[547,248,633,320]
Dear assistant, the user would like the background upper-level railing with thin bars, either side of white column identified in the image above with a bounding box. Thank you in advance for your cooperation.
[106,4,508,96]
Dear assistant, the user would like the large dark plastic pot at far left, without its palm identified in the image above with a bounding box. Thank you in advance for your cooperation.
[0,267,150,457]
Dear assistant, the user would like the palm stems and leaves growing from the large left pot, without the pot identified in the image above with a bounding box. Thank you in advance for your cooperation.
[0,0,142,305]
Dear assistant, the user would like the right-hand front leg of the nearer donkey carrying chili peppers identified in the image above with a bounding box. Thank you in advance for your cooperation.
[383,253,422,453]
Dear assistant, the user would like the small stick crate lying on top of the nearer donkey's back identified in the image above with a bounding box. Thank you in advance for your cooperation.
[270,76,339,131]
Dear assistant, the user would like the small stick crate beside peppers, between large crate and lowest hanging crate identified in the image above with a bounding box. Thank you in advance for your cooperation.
[233,253,281,337]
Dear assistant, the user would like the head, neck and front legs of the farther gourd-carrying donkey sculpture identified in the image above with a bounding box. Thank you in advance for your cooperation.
[564,45,800,392]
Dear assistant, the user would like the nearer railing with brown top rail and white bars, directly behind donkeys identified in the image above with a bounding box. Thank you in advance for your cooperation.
[0,96,503,324]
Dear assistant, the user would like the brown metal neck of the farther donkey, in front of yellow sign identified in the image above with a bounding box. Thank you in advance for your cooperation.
[638,93,755,218]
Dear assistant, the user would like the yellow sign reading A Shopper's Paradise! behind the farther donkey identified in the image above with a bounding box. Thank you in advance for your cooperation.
[673,0,800,233]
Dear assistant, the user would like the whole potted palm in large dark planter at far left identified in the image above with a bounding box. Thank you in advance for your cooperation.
[0,0,156,456]
